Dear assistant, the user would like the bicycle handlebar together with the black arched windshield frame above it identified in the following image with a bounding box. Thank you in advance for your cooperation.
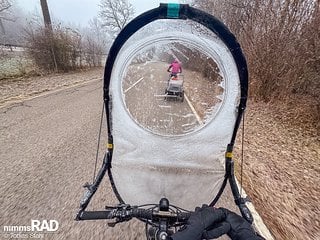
[76,4,253,240]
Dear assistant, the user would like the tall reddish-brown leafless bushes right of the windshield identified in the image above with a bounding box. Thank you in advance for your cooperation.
[194,0,320,127]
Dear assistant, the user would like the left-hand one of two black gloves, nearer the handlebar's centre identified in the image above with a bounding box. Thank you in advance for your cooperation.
[171,205,225,240]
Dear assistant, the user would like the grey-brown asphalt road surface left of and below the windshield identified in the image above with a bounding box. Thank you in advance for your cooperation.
[0,78,236,240]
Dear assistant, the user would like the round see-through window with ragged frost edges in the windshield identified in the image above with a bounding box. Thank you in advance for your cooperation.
[122,41,224,135]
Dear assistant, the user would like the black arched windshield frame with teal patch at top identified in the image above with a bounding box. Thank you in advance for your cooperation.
[103,4,248,210]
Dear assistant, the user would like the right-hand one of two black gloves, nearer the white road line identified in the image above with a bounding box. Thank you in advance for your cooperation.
[204,208,264,240]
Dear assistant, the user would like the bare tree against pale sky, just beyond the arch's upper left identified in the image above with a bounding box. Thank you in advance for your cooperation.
[99,0,134,34]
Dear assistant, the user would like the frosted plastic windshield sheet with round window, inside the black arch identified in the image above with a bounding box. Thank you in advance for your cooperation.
[110,20,240,210]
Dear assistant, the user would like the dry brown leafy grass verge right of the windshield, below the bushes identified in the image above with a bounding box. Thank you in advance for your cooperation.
[236,100,320,240]
